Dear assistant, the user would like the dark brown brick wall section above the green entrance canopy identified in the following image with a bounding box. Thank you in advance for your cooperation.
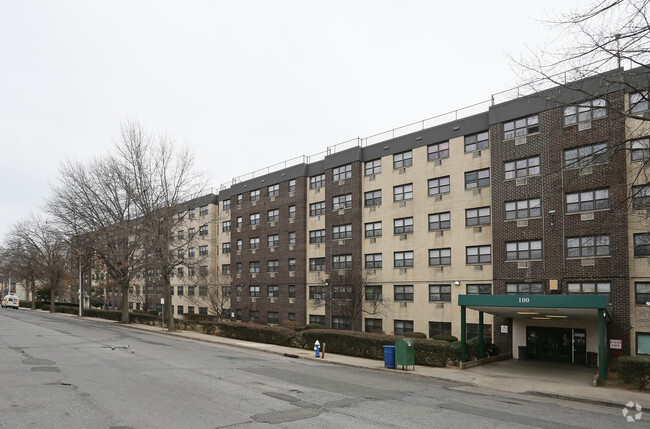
[490,93,629,353]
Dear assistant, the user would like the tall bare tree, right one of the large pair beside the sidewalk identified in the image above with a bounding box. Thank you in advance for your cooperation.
[116,121,207,331]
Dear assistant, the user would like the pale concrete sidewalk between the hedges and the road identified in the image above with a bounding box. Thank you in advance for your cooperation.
[117,324,650,409]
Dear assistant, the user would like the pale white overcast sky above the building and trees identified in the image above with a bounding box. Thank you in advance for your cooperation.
[0,0,584,240]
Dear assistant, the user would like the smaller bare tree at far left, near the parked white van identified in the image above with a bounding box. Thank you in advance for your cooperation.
[10,216,70,313]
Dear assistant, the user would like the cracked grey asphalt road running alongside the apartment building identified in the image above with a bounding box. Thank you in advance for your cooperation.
[0,309,636,429]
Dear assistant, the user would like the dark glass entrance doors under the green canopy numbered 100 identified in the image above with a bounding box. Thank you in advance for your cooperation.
[526,326,587,365]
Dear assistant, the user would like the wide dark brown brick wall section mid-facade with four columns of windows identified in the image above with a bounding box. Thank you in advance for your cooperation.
[225,177,307,325]
